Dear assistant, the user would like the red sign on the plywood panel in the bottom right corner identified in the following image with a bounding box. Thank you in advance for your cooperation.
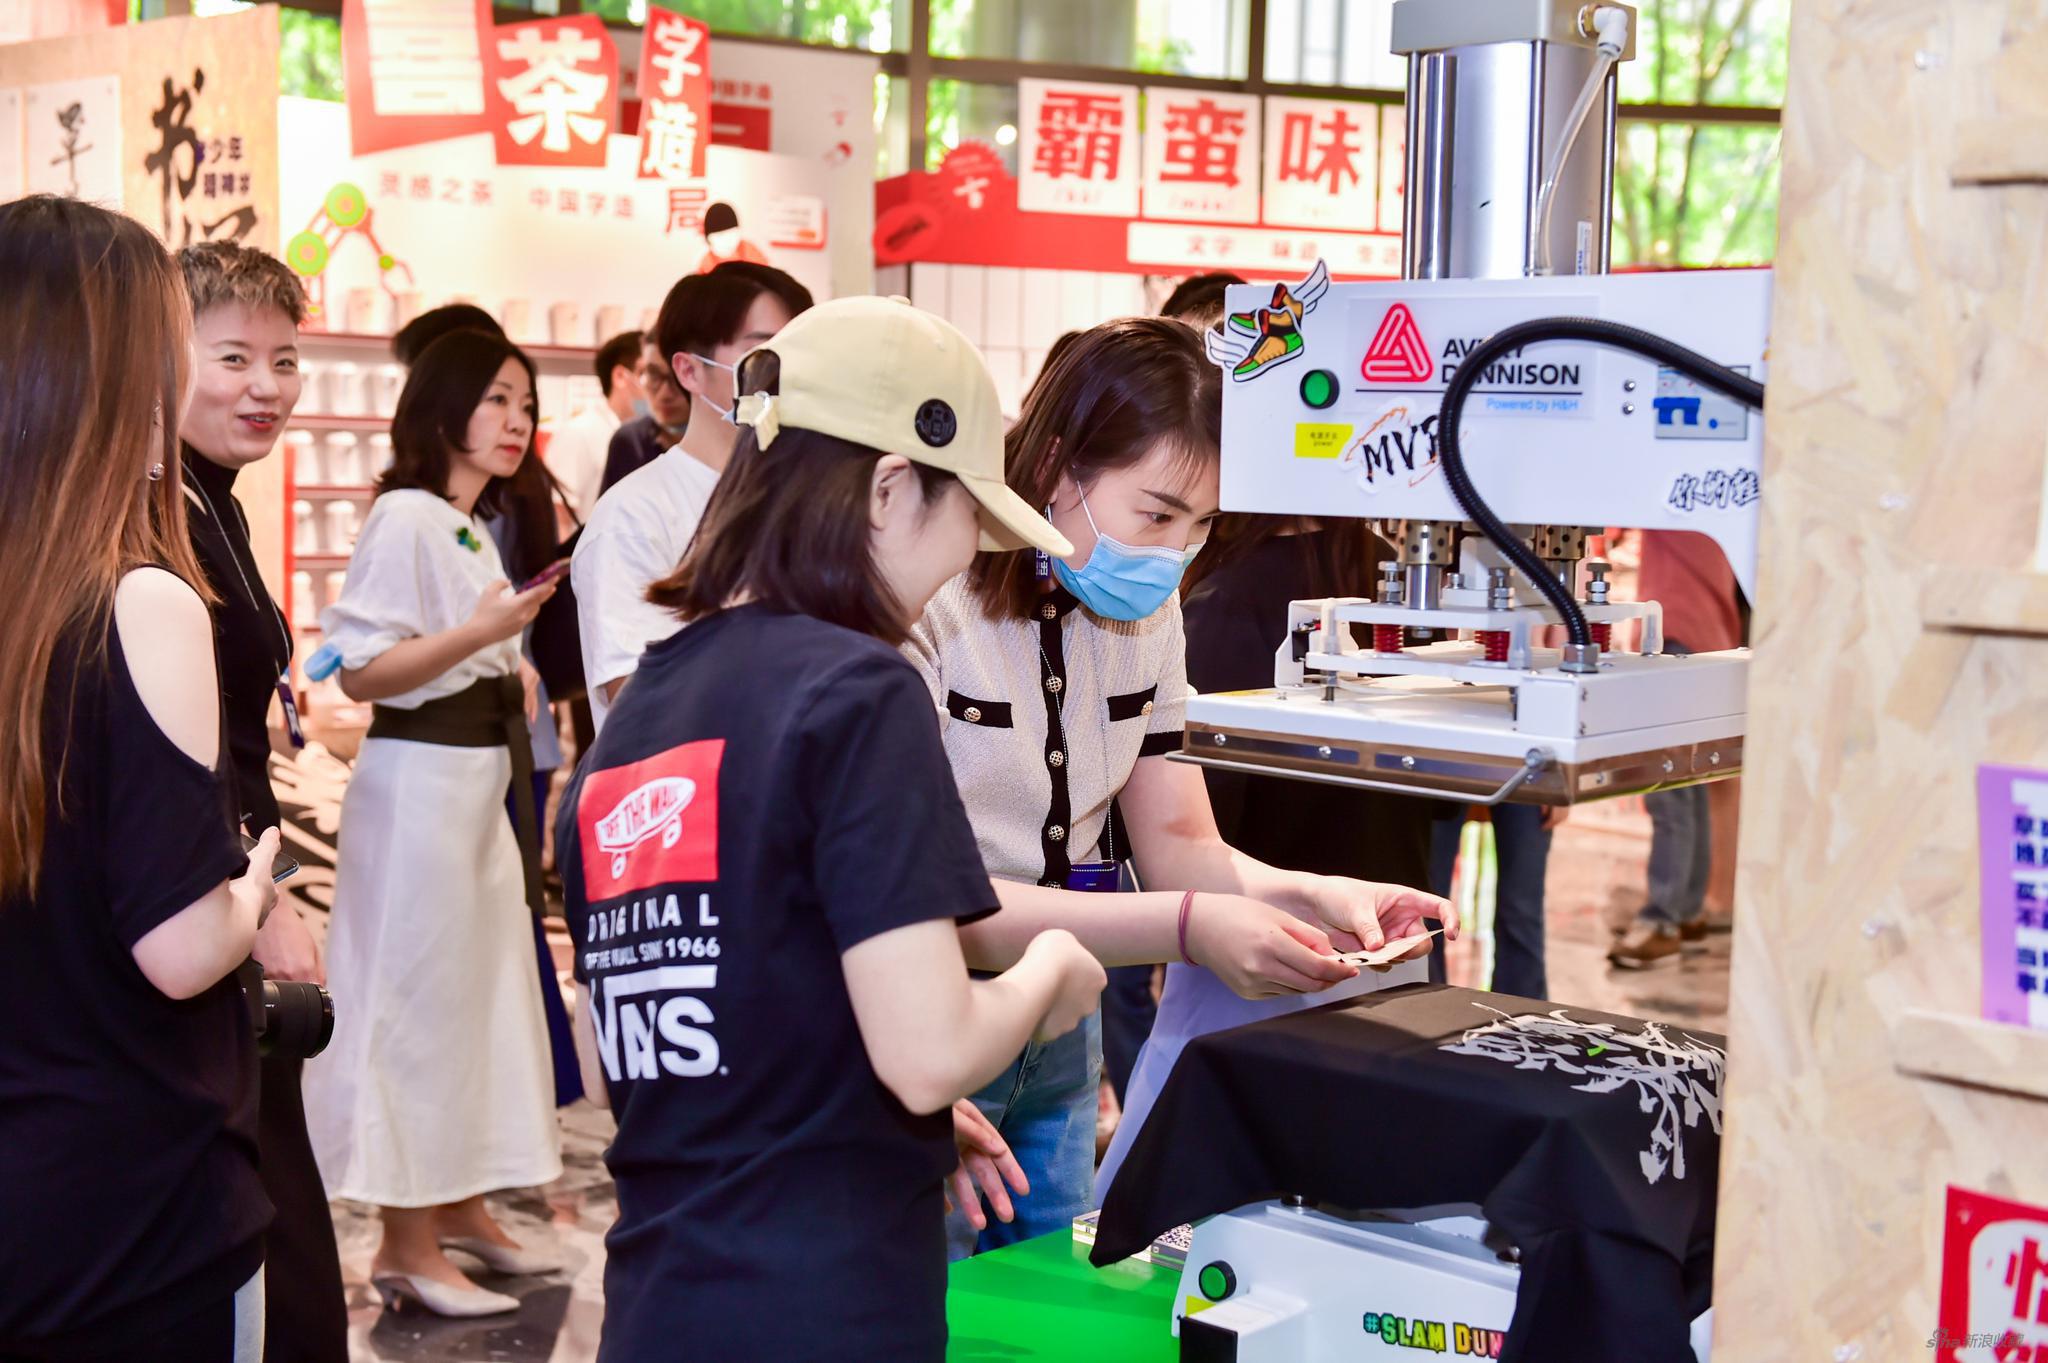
[1927,1187,2048,1363]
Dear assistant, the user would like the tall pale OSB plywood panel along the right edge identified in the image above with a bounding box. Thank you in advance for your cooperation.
[1714,0,2048,1363]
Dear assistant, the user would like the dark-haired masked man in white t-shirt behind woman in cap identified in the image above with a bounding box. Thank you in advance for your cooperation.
[571,262,811,729]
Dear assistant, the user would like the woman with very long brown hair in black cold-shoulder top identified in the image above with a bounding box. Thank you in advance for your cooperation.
[0,196,276,1363]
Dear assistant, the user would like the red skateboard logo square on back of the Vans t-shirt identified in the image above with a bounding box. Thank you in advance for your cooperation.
[575,739,725,905]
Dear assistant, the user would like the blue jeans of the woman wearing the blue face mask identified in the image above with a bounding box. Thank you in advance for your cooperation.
[946,1013,1102,1259]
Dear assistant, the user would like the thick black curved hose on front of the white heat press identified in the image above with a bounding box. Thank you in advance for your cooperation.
[1436,317,1763,647]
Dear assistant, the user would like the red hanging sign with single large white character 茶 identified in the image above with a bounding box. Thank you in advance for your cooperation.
[483,14,618,168]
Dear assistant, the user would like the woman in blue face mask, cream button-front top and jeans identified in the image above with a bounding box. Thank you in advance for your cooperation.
[907,317,1456,1257]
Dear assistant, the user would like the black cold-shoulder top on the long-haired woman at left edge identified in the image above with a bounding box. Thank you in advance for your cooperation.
[0,601,270,1357]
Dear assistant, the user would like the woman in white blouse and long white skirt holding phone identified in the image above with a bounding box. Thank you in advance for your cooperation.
[307,332,561,1316]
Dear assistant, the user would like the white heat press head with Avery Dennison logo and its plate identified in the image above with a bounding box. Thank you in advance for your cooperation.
[1182,270,1772,804]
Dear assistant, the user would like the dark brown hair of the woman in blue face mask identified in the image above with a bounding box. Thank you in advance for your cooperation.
[967,317,1223,618]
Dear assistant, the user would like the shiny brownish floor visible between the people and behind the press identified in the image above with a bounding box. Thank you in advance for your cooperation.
[319,785,1729,1363]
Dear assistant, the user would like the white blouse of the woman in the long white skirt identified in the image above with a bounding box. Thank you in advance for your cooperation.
[319,487,518,710]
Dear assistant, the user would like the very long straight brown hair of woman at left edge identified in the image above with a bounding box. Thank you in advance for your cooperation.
[0,194,211,892]
